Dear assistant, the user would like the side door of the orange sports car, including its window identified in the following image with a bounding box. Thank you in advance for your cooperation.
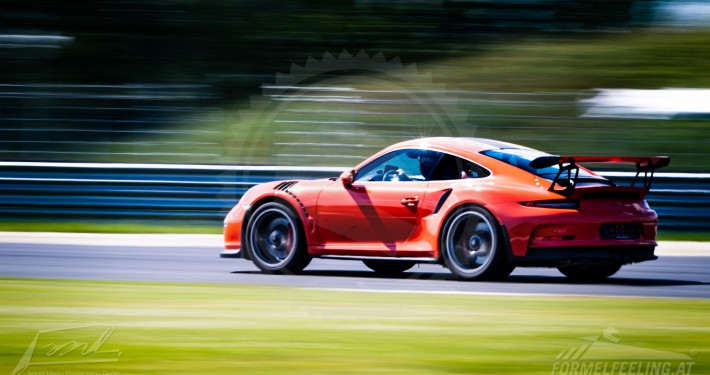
[316,149,439,251]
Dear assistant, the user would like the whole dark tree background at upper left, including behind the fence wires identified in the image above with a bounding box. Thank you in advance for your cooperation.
[0,0,668,160]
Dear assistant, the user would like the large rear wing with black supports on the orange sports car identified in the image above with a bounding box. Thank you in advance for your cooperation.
[530,155,671,197]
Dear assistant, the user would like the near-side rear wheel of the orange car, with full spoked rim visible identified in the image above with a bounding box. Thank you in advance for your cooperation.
[440,206,515,280]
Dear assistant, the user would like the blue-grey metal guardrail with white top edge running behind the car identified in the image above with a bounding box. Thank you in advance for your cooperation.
[0,162,710,231]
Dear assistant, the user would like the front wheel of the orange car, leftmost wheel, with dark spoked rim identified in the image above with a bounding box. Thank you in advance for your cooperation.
[246,202,311,274]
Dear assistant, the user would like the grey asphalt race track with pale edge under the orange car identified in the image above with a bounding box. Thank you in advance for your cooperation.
[0,233,710,298]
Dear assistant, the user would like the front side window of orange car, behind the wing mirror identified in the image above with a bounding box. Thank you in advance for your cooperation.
[355,149,444,182]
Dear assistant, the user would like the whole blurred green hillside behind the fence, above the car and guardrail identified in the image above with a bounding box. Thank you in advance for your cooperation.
[115,31,710,172]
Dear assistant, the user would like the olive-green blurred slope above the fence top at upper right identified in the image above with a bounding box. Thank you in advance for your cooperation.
[432,30,710,92]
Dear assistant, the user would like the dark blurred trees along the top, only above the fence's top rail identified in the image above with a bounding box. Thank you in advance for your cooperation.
[0,0,660,94]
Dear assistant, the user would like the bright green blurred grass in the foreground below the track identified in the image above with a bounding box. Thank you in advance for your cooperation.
[0,279,710,374]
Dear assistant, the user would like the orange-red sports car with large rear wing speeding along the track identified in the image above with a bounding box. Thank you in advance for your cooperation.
[221,137,669,280]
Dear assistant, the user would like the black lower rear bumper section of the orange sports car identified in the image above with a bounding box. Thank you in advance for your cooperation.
[510,245,658,267]
